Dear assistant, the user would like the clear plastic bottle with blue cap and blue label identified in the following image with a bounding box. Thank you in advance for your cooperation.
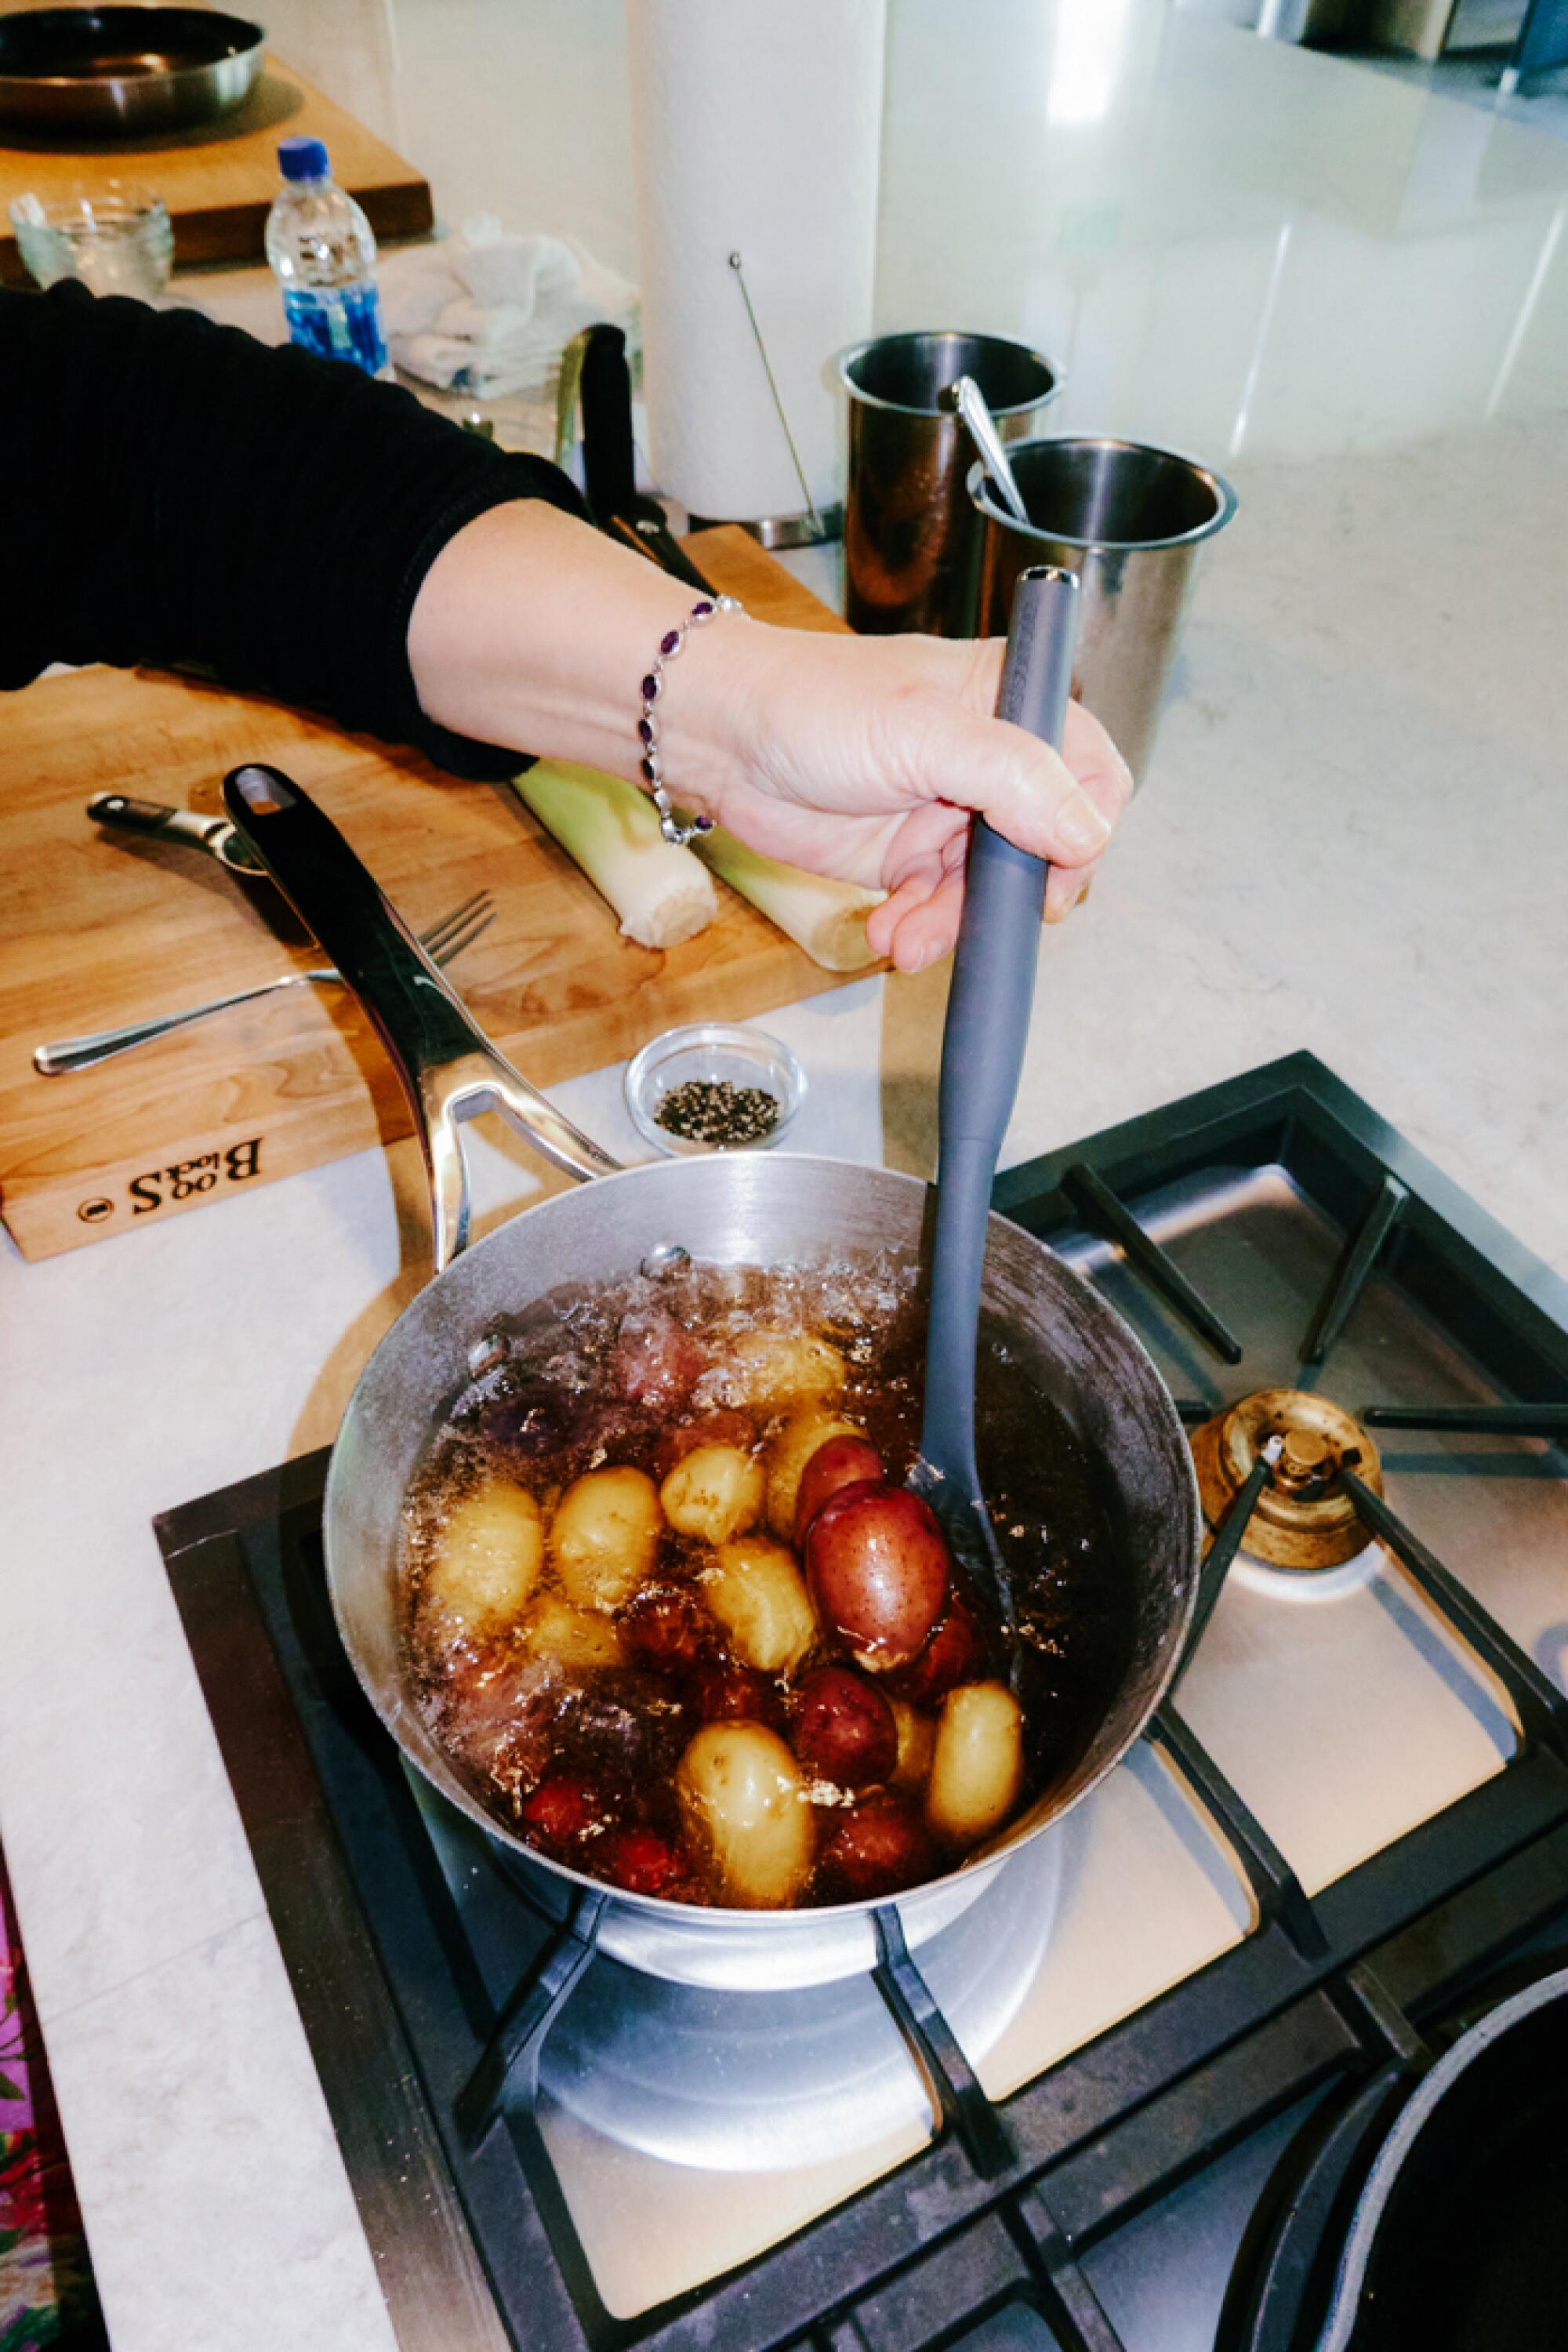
[266,139,393,376]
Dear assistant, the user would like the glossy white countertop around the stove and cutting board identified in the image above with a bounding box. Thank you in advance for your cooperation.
[0,0,1568,2352]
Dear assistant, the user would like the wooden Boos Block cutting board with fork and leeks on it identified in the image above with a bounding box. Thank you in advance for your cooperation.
[0,529,865,1258]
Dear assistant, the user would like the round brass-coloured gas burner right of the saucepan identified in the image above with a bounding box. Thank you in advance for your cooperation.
[1192,1388,1382,1571]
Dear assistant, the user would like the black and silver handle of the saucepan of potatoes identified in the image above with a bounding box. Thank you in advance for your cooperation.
[223,764,621,1275]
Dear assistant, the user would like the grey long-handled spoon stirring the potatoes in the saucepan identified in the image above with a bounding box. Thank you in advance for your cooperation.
[909,564,1079,1628]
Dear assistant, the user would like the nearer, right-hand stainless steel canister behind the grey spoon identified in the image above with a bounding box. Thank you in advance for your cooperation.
[968,440,1236,783]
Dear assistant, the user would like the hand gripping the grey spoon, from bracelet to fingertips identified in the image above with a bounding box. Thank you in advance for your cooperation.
[710,623,1133,971]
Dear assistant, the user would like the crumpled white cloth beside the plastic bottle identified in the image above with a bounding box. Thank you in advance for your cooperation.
[379,212,637,400]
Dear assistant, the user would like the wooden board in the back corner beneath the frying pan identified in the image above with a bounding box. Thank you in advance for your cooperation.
[0,56,435,285]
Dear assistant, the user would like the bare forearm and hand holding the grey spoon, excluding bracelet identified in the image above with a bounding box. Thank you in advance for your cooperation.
[409,501,1133,971]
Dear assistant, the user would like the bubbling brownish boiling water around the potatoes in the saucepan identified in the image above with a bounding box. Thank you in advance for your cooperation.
[405,1263,1133,1903]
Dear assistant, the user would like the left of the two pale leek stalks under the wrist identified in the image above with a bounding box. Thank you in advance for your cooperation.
[513,760,720,948]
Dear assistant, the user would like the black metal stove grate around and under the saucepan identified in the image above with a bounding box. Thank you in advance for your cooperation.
[160,1054,1568,2352]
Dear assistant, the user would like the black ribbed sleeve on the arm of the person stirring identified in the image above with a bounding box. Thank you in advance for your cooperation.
[0,285,583,779]
